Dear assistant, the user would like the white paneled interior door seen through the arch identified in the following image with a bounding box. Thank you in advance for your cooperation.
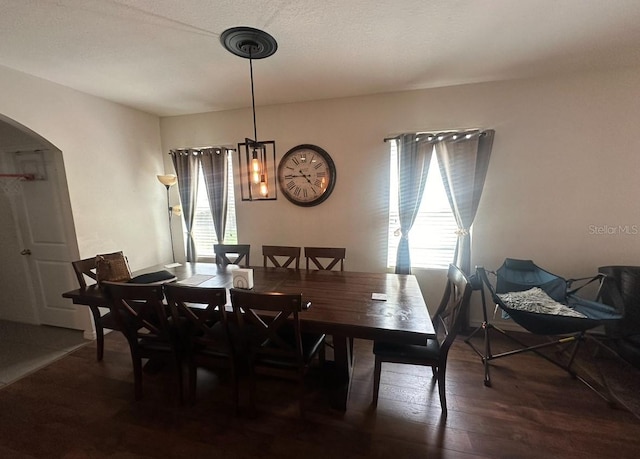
[14,151,89,330]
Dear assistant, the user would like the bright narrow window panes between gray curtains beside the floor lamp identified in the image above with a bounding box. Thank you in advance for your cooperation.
[193,151,238,260]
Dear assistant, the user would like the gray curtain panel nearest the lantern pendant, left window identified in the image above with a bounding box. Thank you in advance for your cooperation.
[199,148,228,244]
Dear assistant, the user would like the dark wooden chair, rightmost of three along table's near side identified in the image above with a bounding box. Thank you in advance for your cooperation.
[230,288,325,416]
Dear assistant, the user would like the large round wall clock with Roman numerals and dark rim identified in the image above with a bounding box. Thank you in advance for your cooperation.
[278,145,336,207]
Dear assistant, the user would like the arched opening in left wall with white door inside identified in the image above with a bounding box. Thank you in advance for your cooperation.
[0,115,93,338]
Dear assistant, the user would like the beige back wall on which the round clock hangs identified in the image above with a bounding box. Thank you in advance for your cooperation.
[161,69,640,319]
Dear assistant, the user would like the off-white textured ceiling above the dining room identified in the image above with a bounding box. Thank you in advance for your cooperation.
[0,0,640,116]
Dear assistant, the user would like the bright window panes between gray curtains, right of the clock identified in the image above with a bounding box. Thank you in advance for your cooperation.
[387,142,458,269]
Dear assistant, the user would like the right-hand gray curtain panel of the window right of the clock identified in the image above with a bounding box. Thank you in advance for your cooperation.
[435,130,494,274]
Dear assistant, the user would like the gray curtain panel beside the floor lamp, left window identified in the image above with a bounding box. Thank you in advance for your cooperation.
[169,150,198,261]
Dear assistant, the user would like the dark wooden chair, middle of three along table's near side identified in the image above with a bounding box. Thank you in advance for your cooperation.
[164,283,238,410]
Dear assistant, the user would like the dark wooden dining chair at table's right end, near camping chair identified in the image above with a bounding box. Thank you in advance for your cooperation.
[373,265,472,416]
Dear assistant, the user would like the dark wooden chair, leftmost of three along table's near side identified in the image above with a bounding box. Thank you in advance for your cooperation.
[101,281,183,402]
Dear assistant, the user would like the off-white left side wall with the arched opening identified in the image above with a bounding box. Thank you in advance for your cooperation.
[0,66,171,269]
